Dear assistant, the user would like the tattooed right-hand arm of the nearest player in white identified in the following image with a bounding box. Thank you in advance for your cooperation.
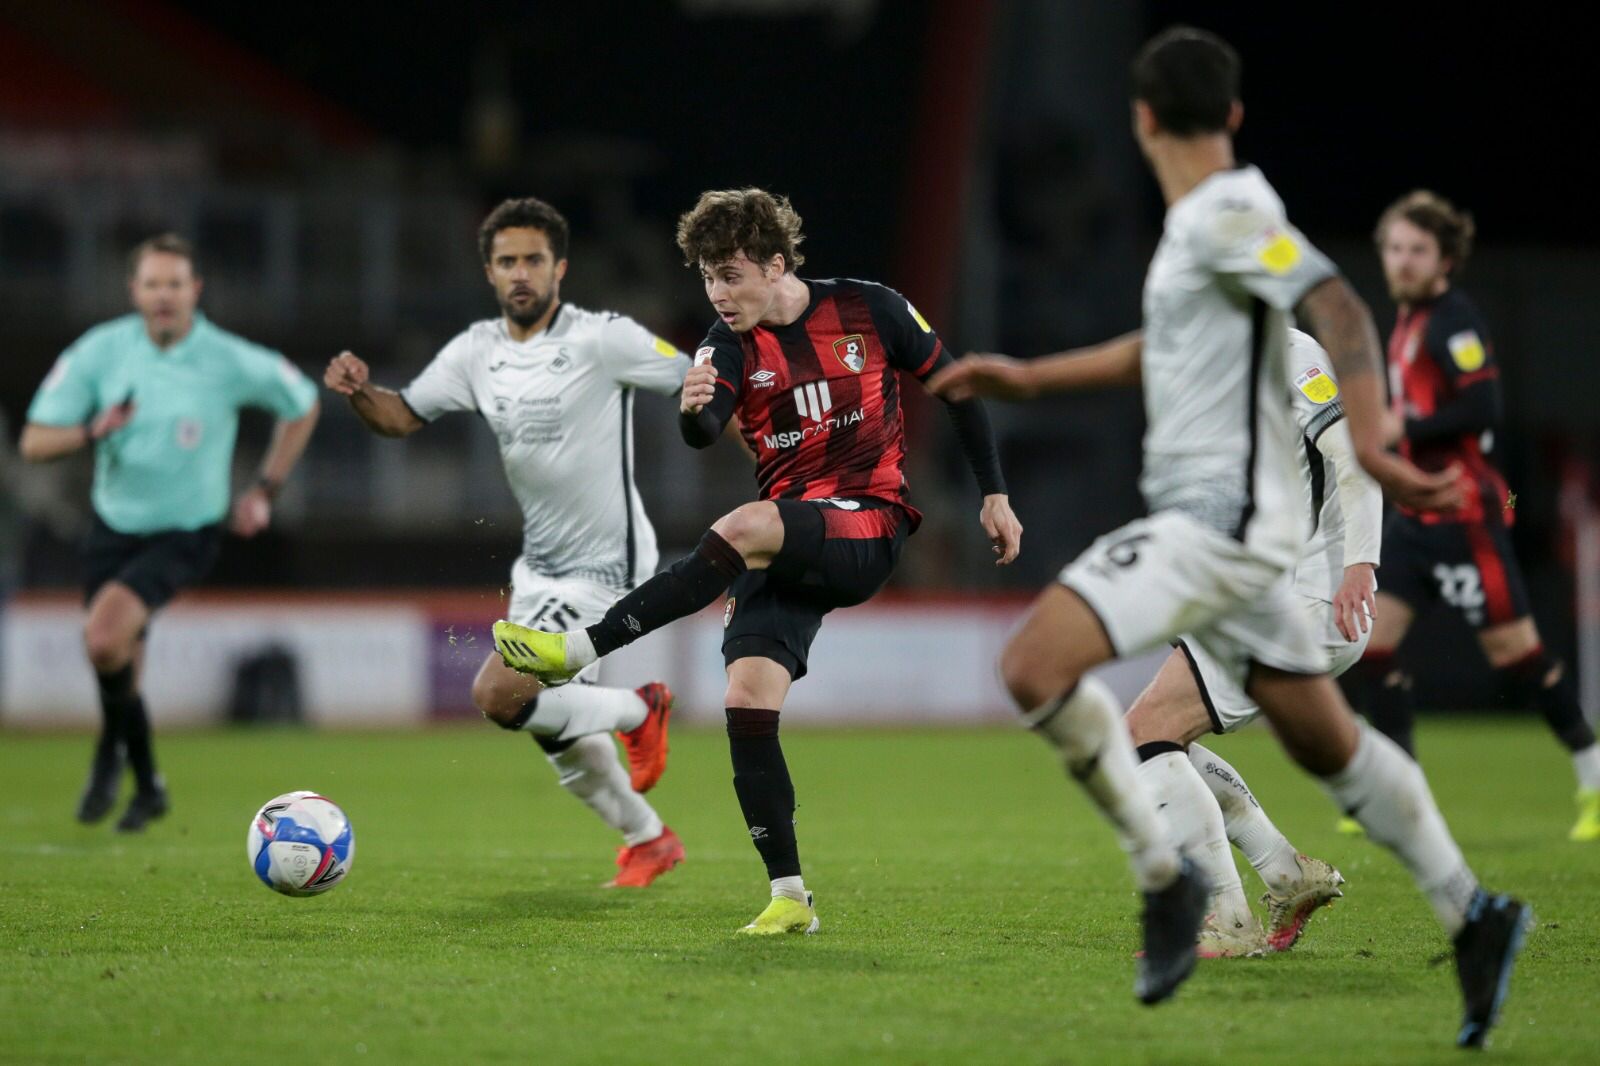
[1296,277,1461,511]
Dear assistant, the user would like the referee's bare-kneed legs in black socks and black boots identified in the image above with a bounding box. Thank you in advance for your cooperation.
[78,581,168,832]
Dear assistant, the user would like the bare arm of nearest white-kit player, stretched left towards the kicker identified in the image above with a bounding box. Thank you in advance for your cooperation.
[928,333,1144,400]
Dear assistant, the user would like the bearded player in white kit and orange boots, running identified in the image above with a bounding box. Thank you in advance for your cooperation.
[323,197,690,887]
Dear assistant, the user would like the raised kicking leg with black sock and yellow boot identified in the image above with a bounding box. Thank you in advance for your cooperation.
[494,501,784,685]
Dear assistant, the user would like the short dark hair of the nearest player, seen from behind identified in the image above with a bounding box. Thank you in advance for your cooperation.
[1133,26,1240,138]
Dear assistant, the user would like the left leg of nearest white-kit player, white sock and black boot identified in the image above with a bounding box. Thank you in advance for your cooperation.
[1000,584,1206,1004]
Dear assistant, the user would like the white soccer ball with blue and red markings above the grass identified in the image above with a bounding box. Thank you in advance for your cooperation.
[246,791,355,896]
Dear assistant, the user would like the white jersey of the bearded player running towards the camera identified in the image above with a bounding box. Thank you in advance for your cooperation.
[400,304,690,589]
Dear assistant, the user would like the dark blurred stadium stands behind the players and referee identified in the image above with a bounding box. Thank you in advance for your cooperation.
[0,0,1600,713]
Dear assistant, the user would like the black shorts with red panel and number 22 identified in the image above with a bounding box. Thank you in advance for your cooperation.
[1378,511,1530,629]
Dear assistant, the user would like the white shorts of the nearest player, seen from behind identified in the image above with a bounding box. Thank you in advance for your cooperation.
[1061,511,1328,674]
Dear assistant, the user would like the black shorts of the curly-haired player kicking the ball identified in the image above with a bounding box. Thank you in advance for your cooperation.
[722,499,909,680]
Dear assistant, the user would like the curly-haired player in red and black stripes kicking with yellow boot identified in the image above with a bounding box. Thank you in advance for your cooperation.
[496,189,1022,935]
